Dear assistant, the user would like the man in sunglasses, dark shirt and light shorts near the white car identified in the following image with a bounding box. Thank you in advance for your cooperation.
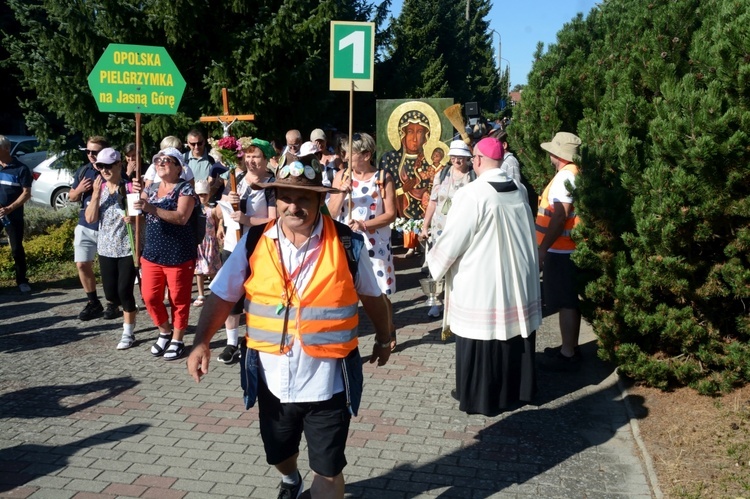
[68,135,109,321]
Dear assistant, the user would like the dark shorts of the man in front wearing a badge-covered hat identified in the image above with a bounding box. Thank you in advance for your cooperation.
[258,378,351,477]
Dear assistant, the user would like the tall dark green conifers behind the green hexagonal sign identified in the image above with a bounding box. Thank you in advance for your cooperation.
[4,0,382,156]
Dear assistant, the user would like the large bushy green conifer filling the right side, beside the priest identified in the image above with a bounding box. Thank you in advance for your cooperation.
[510,0,750,393]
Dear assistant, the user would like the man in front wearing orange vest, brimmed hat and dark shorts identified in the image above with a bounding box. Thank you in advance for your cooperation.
[188,154,390,498]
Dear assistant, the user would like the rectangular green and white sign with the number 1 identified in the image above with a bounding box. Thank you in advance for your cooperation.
[329,21,375,92]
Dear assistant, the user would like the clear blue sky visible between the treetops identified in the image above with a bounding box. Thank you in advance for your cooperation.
[391,0,600,88]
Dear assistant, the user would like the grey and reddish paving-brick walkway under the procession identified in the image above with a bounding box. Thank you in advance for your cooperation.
[0,259,659,499]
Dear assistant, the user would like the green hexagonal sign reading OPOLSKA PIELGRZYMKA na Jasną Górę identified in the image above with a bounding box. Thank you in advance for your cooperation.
[89,43,185,114]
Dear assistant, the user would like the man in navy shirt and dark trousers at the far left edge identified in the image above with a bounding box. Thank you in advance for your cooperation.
[0,135,31,294]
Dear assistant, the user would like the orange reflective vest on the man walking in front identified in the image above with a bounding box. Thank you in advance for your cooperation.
[245,216,359,359]
